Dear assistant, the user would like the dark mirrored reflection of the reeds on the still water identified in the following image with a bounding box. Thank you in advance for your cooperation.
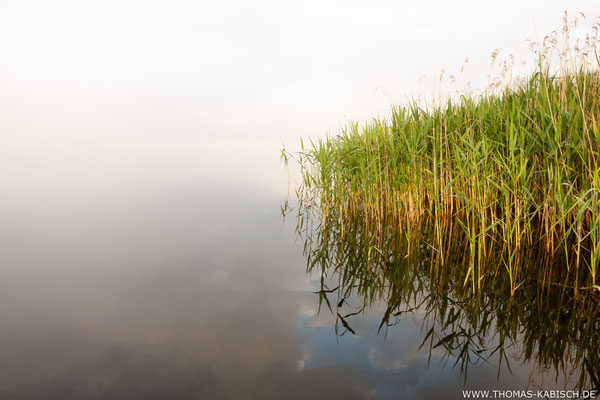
[297,198,600,389]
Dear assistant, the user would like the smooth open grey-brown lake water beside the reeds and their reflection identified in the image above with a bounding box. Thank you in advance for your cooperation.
[0,144,596,399]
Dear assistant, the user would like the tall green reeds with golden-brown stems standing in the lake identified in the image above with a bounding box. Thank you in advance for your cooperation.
[282,14,600,299]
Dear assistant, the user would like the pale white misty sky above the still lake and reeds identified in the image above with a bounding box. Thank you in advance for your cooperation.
[0,0,600,145]
